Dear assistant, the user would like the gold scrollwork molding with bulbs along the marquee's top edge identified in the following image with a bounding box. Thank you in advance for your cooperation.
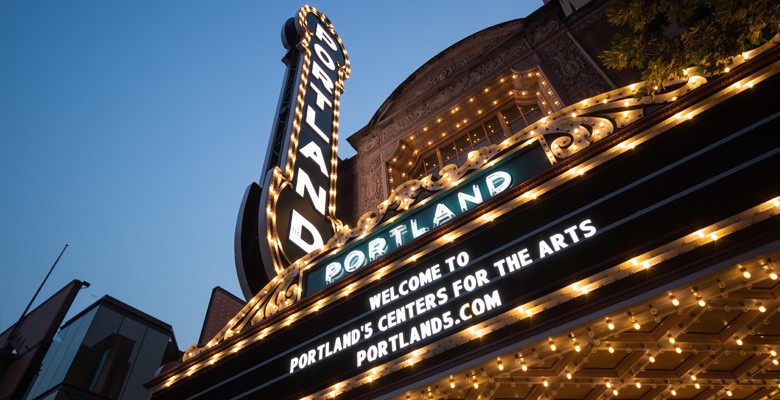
[161,41,778,396]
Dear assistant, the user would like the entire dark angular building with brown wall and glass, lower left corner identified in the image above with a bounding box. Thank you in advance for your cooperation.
[0,280,181,400]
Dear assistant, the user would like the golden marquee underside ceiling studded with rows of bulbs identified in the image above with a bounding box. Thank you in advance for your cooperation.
[395,250,780,400]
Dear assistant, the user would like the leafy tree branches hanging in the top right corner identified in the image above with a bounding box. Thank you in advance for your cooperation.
[599,0,780,94]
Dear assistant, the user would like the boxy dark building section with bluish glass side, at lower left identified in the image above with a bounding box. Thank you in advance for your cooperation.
[25,296,175,400]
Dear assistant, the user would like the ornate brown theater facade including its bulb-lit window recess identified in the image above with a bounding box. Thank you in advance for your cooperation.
[339,2,639,222]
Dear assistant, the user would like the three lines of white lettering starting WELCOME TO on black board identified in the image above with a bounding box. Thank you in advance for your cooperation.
[289,219,597,373]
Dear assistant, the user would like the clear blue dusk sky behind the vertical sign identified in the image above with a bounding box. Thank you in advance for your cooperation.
[0,0,542,349]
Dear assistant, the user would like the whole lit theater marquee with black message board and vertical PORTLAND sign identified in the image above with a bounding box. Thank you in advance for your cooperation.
[148,6,780,400]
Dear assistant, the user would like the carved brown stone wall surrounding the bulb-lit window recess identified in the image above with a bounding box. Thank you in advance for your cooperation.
[339,1,638,226]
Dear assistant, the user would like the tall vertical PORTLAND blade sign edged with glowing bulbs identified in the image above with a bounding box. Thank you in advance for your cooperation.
[235,6,349,296]
